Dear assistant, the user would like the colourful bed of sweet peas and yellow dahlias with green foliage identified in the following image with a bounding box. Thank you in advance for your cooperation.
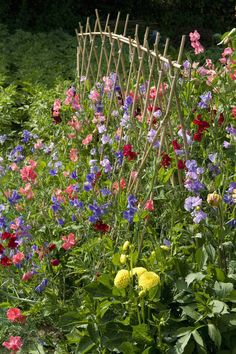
[0,16,236,354]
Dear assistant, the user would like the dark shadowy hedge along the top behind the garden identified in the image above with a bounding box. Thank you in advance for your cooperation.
[0,0,235,34]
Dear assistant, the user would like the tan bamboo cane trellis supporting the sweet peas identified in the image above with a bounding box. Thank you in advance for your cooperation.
[76,10,188,191]
